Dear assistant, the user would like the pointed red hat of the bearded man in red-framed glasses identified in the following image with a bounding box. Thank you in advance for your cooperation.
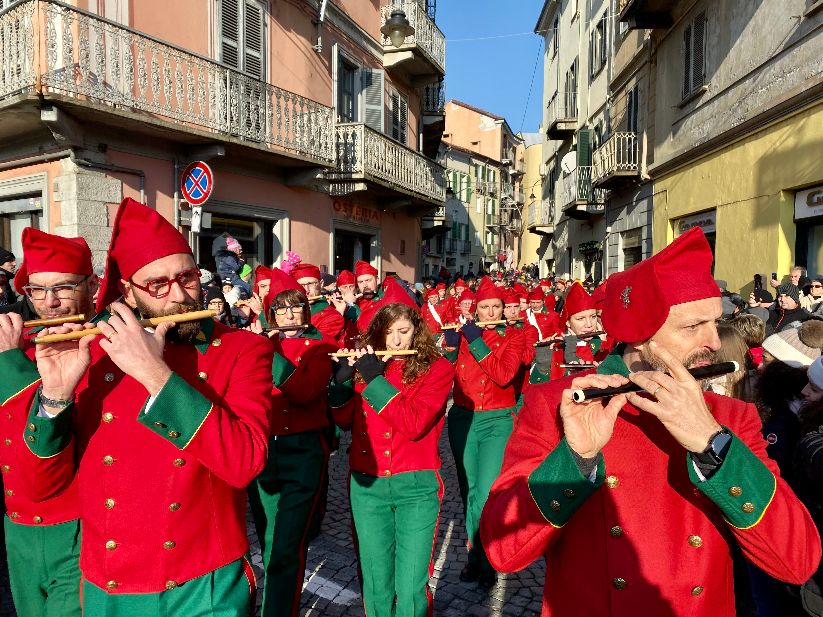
[95,197,192,313]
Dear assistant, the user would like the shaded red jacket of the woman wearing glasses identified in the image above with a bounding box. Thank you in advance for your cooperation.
[271,330,339,435]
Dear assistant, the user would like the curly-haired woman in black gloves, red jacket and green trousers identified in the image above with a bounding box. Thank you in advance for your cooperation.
[331,282,454,617]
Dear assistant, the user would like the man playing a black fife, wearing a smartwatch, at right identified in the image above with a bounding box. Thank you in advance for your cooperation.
[481,228,820,617]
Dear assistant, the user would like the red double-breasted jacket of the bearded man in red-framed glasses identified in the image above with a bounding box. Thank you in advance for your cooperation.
[18,320,272,593]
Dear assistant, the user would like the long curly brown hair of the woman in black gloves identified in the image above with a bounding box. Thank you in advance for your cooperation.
[358,304,440,383]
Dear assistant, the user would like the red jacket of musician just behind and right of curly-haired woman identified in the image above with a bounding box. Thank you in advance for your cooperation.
[446,326,526,411]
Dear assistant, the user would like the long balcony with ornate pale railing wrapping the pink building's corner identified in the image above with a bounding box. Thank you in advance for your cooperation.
[0,0,335,167]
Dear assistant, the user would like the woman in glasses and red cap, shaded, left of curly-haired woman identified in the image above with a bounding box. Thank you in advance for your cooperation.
[249,268,337,617]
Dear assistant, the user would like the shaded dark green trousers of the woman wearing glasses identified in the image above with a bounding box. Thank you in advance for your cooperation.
[249,431,329,617]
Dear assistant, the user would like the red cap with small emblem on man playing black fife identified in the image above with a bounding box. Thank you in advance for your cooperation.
[603,227,720,343]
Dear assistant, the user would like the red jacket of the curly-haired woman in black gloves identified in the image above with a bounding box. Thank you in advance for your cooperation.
[332,358,454,477]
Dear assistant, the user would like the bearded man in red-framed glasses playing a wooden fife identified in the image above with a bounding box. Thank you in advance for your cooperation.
[16,198,272,617]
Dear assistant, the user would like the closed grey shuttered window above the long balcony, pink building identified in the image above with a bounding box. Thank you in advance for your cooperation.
[217,0,265,80]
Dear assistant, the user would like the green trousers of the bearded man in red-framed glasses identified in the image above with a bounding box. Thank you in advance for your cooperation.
[83,559,255,617]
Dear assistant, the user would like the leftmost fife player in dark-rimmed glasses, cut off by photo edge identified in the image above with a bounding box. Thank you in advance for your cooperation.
[0,227,98,617]
